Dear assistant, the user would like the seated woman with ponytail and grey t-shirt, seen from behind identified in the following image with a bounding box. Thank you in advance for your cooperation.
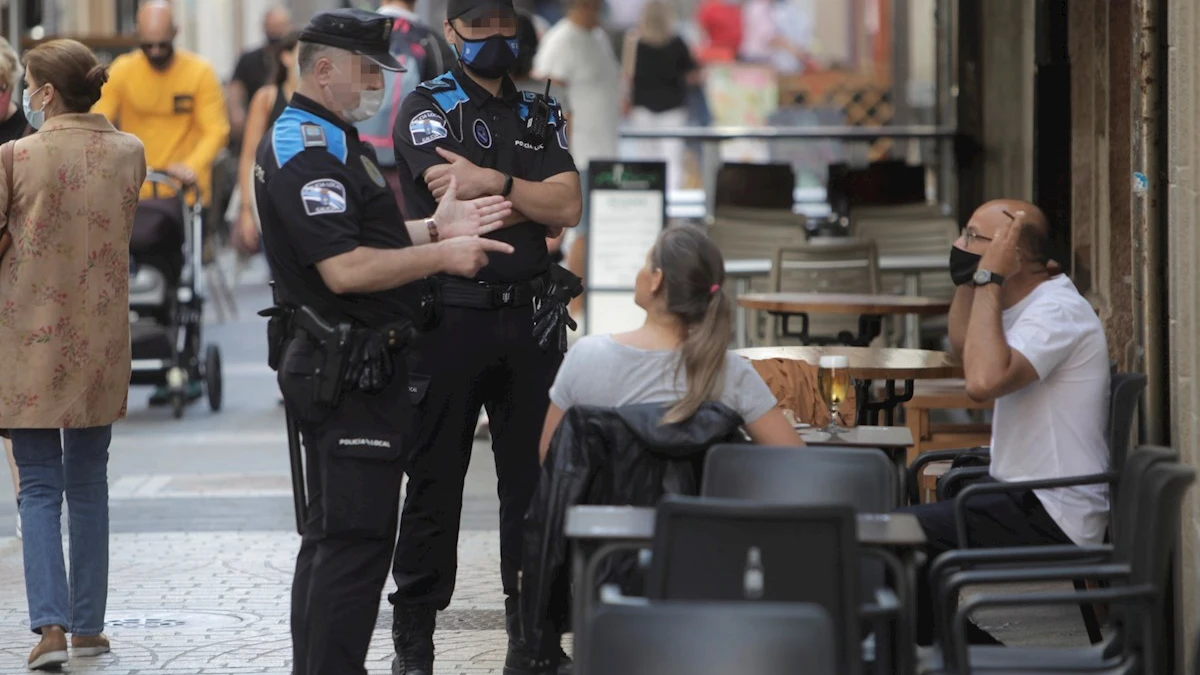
[541,226,803,458]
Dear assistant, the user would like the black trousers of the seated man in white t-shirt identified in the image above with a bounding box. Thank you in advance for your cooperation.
[900,480,1072,645]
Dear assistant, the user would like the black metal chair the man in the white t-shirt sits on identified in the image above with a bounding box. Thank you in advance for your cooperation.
[908,372,1146,645]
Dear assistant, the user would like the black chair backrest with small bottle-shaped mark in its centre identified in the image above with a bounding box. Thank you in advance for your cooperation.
[648,494,862,674]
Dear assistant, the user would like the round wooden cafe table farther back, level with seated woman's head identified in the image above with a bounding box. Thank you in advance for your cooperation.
[738,293,950,347]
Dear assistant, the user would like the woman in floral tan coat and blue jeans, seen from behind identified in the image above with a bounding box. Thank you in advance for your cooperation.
[0,40,146,669]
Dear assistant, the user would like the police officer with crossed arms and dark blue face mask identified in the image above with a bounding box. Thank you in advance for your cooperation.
[390,0,582,675]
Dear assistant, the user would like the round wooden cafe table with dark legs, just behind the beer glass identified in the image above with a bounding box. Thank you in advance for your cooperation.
[737,347,962,426]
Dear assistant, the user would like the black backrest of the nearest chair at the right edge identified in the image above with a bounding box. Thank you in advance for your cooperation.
[1122,454,1195,673]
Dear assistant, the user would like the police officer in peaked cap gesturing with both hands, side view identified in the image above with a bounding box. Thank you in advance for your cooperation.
[254,10,512,675]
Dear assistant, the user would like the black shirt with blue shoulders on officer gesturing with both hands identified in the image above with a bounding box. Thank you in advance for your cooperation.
[254,94,416,327]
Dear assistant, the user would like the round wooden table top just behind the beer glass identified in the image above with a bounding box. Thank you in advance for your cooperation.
[737,346,962,380]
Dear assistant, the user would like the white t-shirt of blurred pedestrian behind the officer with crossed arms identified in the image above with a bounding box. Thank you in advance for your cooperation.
[533,19,620,171]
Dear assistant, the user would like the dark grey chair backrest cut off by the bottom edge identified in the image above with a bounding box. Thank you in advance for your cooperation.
[587,602,839,675]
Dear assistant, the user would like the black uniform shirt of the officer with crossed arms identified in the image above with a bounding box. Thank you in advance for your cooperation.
[392,65,576,282]
